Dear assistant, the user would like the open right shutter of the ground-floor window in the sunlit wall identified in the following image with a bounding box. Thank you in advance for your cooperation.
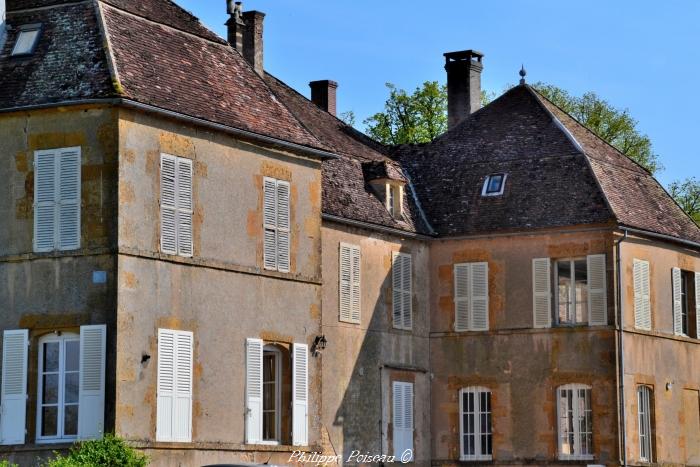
[292,344,309,446]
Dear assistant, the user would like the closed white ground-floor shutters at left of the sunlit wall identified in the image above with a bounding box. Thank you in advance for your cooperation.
[156,329,194,443]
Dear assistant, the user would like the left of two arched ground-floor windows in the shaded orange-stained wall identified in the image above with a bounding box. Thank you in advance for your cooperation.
[459,387,493,461]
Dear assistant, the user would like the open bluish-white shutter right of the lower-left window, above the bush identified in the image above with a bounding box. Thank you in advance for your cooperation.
[78,325,107,439]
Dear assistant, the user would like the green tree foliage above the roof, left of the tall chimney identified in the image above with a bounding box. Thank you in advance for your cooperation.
[364,81,447,145]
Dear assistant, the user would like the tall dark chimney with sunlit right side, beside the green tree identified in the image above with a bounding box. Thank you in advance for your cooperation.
[445,50,484,129]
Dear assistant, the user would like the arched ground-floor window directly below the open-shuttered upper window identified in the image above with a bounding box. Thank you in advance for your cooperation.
[557,384,593,460]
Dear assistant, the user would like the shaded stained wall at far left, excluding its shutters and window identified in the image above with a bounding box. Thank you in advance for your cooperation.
[0,106,118,459]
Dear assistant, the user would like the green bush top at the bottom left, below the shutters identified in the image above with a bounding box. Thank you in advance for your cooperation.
[45,435,148,467]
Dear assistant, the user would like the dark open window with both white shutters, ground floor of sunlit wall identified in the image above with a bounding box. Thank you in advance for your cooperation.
[245,339,309,446]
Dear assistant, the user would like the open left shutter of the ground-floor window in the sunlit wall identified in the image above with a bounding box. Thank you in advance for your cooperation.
[246,339,263,444]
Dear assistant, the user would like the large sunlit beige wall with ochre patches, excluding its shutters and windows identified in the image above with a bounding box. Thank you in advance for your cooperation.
[116,110,321,465]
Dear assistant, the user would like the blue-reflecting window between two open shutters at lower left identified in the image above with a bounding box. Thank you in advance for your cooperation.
[37,333,80,442]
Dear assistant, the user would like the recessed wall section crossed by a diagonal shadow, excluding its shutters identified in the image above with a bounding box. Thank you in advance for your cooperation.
[322,222,431,465]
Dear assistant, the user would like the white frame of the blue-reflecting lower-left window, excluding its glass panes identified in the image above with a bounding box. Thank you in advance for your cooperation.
[36,333,80,444]
